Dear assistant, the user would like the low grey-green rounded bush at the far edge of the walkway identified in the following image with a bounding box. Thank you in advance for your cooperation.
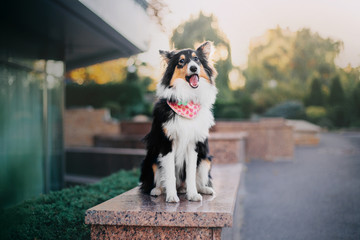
[264,101,305,119]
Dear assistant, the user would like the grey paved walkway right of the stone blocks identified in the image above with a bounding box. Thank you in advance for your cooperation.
[240,132,360,240]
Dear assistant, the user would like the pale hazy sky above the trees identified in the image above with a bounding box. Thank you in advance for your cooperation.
[139,0,360,70]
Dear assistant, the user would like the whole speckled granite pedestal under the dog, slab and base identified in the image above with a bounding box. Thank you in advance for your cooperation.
[85,164,243,239]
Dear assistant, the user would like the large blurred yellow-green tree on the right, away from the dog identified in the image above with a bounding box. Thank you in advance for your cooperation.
[244,27,342,113]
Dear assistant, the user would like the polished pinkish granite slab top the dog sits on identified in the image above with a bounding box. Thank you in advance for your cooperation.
[85,164,243,227]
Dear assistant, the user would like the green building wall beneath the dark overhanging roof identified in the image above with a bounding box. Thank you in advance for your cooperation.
[0,57,64,208]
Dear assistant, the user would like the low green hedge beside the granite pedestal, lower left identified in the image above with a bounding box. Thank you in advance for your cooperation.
[0,170,139,239]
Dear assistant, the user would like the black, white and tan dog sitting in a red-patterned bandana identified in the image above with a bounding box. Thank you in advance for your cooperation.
[140,41,217,202]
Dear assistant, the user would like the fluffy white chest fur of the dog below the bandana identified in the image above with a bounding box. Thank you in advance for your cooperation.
[163,109,214,144]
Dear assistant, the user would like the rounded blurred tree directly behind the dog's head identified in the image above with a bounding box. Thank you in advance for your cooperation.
[170,12,233,102]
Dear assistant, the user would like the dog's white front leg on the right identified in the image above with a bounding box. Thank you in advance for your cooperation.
[186,144,202,202]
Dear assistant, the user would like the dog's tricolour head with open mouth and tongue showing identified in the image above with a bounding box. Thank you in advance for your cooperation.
[158,41,217,104]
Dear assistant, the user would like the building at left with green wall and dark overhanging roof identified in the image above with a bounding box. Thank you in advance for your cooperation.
[0,0,148,208]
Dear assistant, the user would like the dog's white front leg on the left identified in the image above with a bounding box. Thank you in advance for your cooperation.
[159,152,179,202]
